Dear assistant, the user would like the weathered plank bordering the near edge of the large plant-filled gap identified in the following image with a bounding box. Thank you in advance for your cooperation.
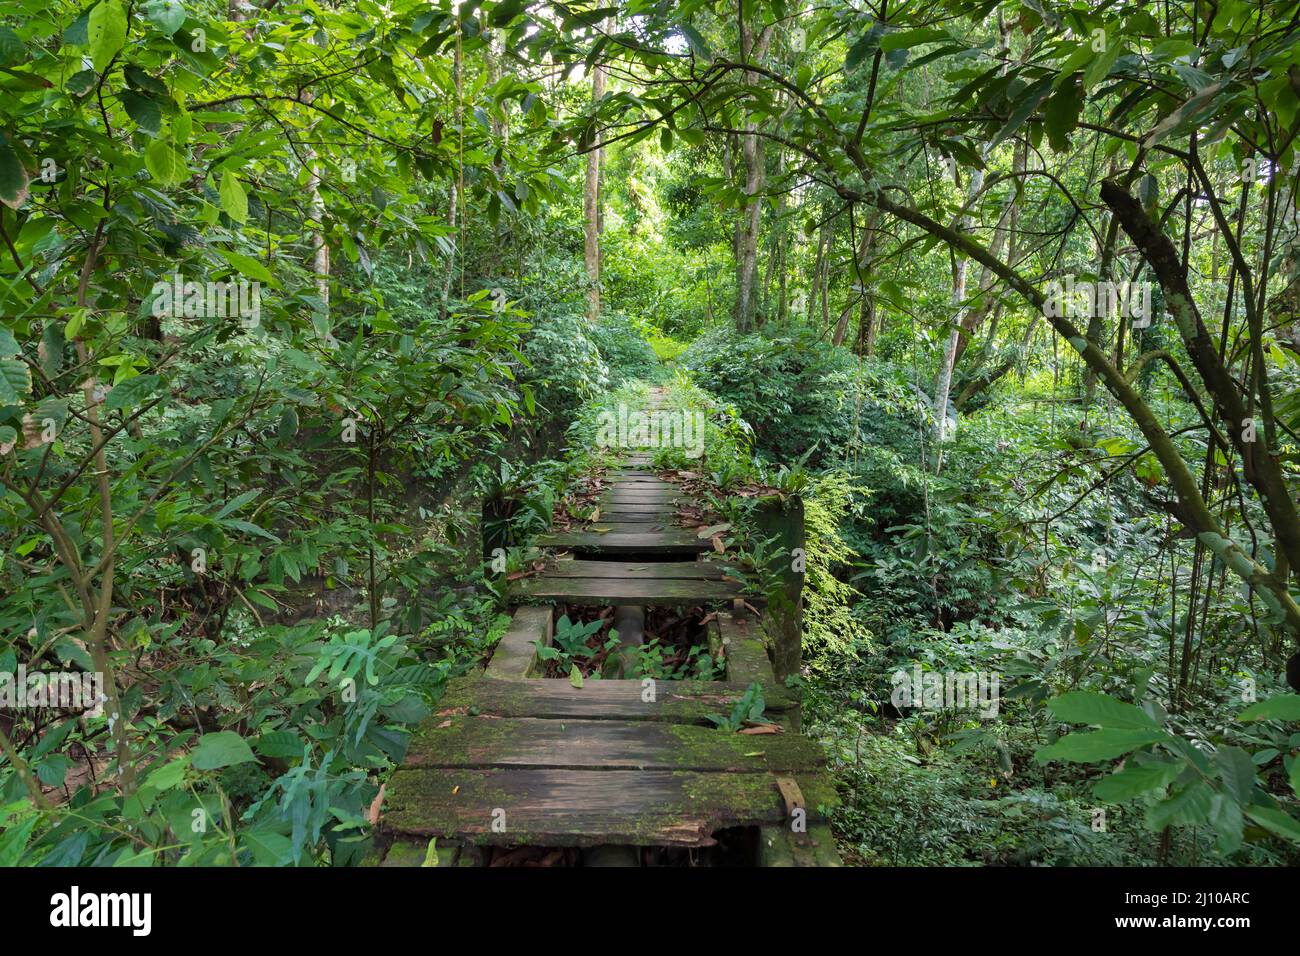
[430,675,798,727]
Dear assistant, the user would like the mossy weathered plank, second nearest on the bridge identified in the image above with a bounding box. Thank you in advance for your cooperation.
[406,715,826,775]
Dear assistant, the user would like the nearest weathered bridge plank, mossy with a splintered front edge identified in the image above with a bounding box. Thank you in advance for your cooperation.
[384,767,835,847]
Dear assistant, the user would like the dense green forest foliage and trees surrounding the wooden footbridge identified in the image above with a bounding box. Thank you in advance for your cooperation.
[0,0,1300,865]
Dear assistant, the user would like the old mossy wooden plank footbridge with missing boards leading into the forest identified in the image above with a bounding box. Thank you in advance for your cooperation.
[381,390,839,866]
